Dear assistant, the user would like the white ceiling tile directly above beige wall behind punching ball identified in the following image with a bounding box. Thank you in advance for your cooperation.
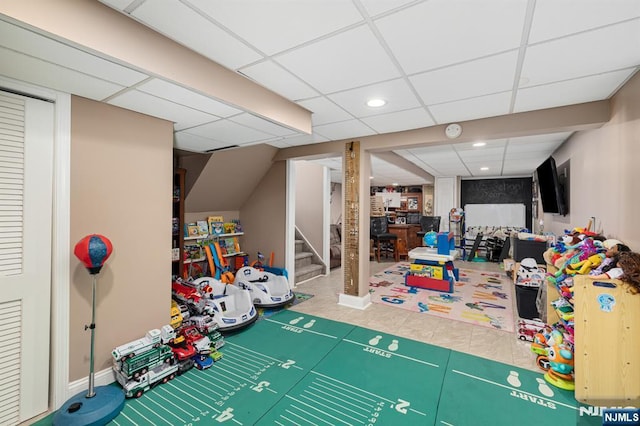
[107,90,220,130]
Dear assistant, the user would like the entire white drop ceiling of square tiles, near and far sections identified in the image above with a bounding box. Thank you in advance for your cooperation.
[0,0,640,185]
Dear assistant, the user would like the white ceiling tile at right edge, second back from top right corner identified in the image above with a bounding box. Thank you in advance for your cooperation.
[521,19,640,87]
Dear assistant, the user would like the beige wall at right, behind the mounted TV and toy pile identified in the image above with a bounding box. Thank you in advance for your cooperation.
[544,70,640,251]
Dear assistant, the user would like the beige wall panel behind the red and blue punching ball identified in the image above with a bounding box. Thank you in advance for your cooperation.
[69,97,173,381]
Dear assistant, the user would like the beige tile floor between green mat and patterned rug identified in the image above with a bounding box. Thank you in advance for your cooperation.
[291,261,540,372]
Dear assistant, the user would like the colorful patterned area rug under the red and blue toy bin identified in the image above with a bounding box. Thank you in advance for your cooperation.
[369,262,514,332]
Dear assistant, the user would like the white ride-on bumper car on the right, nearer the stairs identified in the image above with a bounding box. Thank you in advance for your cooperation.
[233,266,295,308]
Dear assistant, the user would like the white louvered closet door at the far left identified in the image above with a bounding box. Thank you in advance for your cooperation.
[0,91,54,425]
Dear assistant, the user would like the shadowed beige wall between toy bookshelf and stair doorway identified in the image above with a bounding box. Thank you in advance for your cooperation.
[240,161,287,267]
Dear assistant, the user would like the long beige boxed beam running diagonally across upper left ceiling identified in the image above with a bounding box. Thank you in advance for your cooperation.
[0,0,311,134]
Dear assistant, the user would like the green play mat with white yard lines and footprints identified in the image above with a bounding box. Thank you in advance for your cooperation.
[39,310,602,426]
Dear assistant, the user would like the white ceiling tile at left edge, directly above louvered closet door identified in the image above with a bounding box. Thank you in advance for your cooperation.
[0,47,123,100]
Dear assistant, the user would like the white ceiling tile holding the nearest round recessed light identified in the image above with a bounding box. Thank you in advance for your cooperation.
[328,78,420,118]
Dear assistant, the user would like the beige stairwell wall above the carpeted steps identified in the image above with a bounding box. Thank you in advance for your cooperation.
[294,161,328,257]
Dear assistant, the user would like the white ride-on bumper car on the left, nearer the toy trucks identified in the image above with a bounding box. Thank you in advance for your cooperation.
[195,277,258,332]
